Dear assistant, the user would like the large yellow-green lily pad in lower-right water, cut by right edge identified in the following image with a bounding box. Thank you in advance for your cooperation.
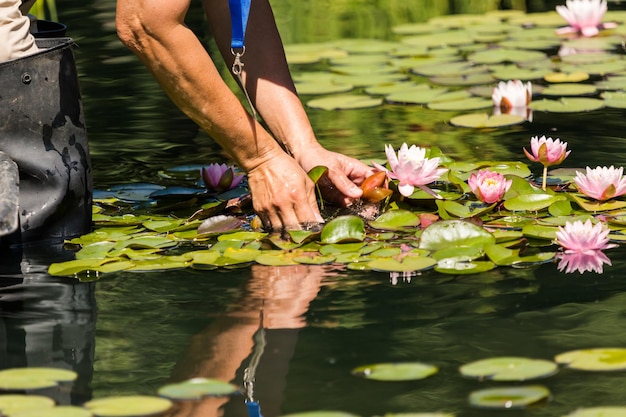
[554,348,626,371]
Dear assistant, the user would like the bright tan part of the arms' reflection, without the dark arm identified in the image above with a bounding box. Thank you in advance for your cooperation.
[165,265,327,417]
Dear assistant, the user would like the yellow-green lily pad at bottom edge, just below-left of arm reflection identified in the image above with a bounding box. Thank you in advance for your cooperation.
[84,395,172,417]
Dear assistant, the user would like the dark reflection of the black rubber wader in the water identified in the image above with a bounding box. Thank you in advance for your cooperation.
[0,252,97,405]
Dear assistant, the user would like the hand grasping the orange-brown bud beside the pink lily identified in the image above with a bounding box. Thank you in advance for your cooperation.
[298,146,375,207]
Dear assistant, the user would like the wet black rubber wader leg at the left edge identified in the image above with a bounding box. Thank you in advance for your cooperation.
[0,38,92,247]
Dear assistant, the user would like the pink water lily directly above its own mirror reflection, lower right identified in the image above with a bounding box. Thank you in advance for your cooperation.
[556,220,616,253]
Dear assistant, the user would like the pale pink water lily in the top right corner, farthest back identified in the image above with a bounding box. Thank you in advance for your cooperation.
[556,0,617,37]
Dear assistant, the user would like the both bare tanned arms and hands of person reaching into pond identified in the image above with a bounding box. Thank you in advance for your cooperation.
[116,0,373,229]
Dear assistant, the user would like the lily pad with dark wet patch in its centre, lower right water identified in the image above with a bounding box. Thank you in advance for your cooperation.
[469,385,551,410]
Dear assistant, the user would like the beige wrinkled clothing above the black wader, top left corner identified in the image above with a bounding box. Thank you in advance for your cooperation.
[0,0,39,62]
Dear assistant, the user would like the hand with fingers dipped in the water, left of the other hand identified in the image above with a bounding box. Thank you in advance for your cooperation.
[248,153,324,230]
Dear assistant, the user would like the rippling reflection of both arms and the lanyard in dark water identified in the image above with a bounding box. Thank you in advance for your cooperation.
[163,265,339,417]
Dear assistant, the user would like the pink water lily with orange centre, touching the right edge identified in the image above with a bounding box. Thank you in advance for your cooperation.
[574,165,626,201]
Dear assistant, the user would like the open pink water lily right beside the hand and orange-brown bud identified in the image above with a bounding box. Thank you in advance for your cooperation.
[372,143,448,197]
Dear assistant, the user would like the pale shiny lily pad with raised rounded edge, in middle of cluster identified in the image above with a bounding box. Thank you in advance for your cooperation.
[419,220,495,250]
